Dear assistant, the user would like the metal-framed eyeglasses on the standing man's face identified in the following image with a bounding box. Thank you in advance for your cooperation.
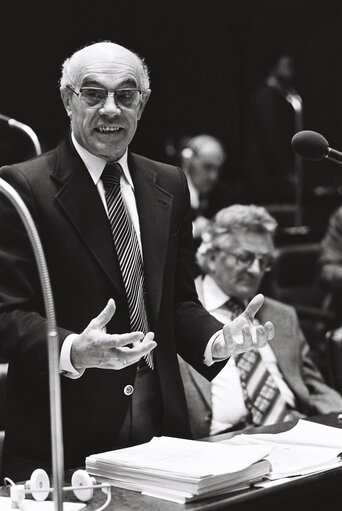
[67,85,142,108]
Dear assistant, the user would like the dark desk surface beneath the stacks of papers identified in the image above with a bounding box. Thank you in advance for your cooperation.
[0,413,342,511]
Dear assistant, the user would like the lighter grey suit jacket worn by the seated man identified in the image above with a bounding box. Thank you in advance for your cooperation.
[180,298,342,438]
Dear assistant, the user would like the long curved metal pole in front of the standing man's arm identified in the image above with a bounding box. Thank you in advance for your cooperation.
[0,178,64,511]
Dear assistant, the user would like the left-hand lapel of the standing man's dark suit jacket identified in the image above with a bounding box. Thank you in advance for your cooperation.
[52,139,125,296]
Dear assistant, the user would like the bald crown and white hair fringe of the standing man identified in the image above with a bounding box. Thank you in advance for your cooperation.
[60,41,150,91]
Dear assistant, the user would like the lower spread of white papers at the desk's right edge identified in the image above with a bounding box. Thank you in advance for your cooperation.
[220,419,342,480]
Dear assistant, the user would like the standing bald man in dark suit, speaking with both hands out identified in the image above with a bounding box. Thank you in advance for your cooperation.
[0,42,273,480]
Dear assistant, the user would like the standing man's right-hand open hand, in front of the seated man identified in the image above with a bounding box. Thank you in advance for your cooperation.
[212,294,274,359]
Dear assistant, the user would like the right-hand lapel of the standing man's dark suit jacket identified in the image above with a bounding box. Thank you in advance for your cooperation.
[128,155,172,325]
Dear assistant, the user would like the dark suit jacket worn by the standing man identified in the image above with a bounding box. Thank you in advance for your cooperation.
[0,133,221,475]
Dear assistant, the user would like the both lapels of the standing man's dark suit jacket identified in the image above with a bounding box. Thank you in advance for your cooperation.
[52,137,176,324]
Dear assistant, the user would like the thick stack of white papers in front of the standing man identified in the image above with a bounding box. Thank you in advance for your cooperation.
[86,437,271,503]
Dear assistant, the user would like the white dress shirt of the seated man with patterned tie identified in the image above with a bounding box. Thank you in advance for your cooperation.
[198,275,295,435]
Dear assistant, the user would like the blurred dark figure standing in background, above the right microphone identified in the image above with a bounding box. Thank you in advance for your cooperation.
[246,51,303,203]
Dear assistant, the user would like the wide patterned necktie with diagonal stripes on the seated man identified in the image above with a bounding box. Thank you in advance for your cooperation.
[226,298,294,426]
